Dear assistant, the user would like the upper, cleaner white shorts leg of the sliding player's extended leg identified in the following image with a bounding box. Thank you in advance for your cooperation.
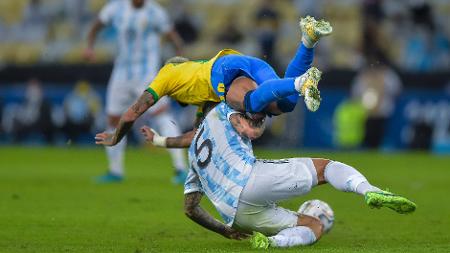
[241,158,317,205]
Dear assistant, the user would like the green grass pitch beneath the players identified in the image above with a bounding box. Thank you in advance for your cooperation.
[0,147,450,253]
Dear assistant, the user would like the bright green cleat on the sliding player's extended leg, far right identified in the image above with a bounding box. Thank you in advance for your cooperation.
[365,191,416,214]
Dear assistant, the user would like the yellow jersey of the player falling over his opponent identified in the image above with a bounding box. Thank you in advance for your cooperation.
[147,49,241,107]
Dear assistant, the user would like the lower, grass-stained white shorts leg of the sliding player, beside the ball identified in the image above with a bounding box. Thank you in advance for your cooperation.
[233,202,298,235]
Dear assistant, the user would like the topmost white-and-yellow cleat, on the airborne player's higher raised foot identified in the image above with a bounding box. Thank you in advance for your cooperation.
[299,16,333,46]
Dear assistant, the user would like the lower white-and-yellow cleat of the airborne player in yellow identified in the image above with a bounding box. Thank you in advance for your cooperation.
[295,67,322,112]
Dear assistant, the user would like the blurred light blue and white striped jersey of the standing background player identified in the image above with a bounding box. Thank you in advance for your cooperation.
[99,0,172,82]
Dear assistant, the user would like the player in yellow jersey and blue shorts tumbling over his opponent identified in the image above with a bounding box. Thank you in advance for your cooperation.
[95,16,332,146]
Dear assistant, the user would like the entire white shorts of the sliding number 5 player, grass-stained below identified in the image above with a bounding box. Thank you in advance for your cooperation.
[233,158,317,235]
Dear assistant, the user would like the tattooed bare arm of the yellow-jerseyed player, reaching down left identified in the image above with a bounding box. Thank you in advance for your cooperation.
[95,91,155,146]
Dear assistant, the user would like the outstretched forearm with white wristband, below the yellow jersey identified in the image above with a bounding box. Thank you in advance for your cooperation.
[141,126,197,148]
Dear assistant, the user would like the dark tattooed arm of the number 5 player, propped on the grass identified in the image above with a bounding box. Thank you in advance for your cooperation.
[184,192,248,240]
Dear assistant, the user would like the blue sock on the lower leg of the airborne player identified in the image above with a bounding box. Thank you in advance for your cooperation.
[244,78,298,113]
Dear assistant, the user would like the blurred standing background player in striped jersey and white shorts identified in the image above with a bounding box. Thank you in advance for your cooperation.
[85,0,186,183]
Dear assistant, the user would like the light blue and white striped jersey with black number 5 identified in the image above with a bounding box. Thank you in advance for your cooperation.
[184,102,256,225]
